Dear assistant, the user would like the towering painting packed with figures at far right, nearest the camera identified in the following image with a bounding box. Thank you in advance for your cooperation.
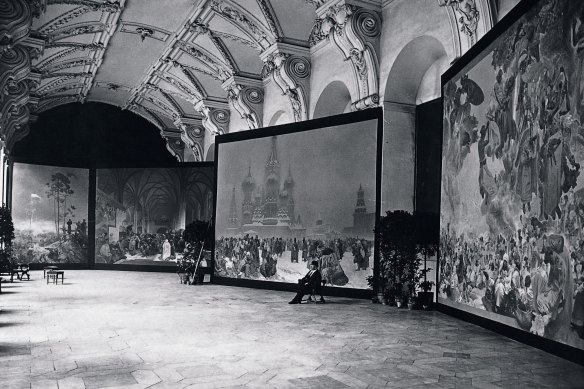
[439,0,584,349]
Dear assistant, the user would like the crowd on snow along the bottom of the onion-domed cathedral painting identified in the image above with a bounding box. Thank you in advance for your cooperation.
[215,235,373,288]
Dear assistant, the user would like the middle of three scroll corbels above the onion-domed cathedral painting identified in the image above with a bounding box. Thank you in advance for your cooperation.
[260,43,311,122]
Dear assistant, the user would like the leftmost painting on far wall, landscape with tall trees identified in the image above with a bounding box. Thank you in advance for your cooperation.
[12,163,89,264]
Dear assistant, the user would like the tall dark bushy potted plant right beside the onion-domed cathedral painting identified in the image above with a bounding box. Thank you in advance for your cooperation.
[375,210,417,306]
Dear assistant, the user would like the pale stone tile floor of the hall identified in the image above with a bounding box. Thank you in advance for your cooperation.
[0,270,584,389]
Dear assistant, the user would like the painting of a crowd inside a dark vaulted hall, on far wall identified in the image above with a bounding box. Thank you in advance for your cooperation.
[95,166,214,266]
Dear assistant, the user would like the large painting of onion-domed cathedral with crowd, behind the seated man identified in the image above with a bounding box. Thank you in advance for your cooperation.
[215,115,378,289]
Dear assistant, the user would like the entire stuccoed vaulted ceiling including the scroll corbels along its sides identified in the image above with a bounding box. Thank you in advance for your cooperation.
[0,0,502,160]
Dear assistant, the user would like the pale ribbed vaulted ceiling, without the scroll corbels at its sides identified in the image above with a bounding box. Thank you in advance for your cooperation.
[22,0,325,159]
